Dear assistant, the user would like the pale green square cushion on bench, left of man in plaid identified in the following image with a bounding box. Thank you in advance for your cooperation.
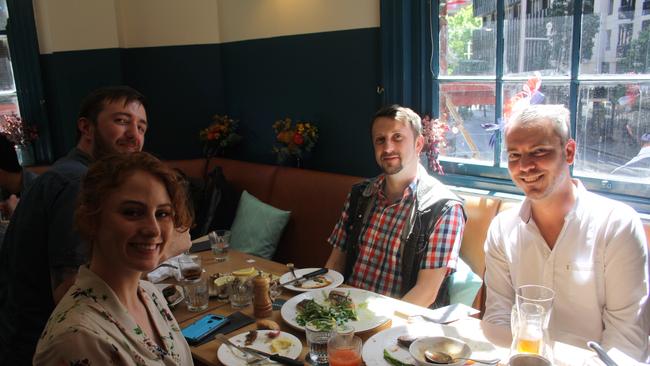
[230,191,291,259]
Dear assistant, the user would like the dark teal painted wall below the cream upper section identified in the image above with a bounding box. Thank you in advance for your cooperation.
[41,28,380,176]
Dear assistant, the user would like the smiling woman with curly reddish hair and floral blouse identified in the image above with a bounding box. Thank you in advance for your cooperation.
[34,152,192,365]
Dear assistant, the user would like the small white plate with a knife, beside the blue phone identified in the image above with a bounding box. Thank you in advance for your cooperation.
[217,330,302,366]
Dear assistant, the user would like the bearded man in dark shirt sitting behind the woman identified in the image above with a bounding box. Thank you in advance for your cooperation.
[0,86,189,365]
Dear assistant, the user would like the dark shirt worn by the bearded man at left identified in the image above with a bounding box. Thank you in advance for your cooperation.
[0,149,91,365]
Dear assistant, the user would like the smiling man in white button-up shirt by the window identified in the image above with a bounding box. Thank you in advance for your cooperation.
[483,105,650,360]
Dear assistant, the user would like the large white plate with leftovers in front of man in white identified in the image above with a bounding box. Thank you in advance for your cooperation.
[361,322,502,366]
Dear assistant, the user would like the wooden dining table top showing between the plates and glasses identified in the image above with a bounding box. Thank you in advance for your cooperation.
[166,250,597,366]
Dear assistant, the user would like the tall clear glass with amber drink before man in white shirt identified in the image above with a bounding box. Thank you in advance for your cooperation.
[510,285,555,360]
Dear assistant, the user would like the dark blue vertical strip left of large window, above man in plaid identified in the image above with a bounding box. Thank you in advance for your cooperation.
[380,0,438,115]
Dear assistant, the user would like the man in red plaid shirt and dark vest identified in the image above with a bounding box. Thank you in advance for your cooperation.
[325,105,465,307]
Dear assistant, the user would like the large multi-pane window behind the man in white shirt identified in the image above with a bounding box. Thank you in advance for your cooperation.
[431,0,650,212]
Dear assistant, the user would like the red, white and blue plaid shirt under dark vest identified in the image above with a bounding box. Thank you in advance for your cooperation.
[327,175,465,297]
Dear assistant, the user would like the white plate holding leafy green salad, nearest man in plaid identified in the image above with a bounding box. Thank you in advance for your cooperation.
[280,288,394,332]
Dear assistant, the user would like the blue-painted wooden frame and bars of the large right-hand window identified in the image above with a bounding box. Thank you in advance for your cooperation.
[381,0,650,213]
